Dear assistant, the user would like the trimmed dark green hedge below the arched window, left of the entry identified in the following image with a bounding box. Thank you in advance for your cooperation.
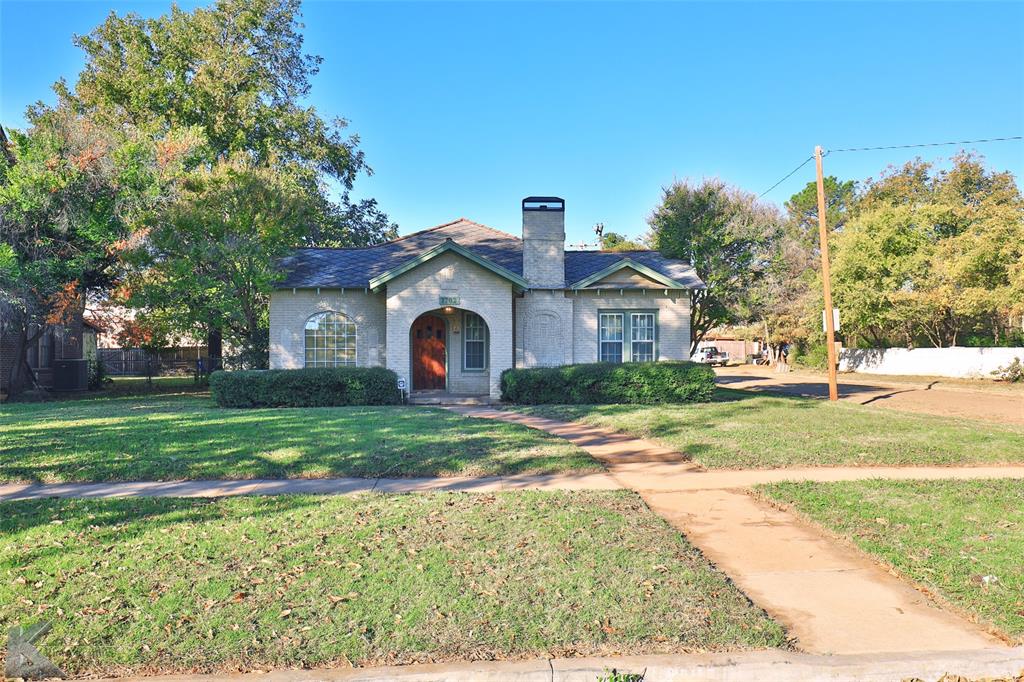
[210,367,401,408]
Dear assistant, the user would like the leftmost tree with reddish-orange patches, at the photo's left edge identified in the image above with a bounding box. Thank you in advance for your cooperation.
[0,111,181,393]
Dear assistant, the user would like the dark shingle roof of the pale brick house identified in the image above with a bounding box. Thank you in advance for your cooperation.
[278,218,703,289]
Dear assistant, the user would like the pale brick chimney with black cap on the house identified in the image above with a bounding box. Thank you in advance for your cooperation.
[522,197,565,289]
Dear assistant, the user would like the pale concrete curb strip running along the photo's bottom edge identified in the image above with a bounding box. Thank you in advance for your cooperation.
[88,648,1024,682]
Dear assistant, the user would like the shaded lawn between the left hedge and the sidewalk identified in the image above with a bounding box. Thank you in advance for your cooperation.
[0,393,601,482]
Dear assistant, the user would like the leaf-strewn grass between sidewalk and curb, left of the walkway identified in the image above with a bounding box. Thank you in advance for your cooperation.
[0,492,786,675]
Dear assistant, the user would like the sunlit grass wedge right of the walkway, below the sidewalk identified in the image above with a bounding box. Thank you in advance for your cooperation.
[757,479,1024,644]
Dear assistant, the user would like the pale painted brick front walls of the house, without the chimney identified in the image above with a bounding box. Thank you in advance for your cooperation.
[270,260,690,396]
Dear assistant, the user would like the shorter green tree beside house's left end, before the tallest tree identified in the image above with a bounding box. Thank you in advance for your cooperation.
[121,162,314,368]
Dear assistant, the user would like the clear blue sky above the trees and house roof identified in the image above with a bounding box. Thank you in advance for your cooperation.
[0,0,1024,242]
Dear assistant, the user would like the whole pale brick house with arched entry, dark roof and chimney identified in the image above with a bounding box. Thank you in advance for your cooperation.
[270,197,703,397]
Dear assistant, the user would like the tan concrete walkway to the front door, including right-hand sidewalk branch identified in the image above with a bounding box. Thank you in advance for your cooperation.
[453,408,1024,654]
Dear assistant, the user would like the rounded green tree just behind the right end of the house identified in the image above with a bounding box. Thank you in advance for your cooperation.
[647,179,781,350]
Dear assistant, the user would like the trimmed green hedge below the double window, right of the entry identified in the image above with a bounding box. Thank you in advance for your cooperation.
[502,363,715,404]
